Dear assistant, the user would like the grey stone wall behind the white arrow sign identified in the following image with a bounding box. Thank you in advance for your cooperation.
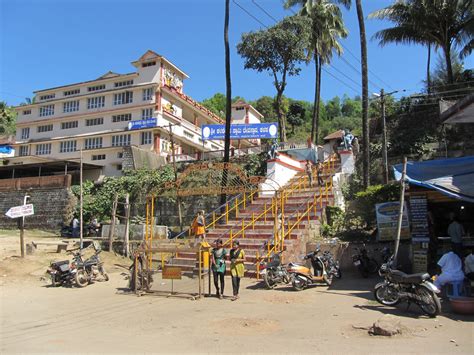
[0,188,76,229]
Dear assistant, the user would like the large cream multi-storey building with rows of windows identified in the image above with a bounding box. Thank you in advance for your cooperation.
[11,50,262,176]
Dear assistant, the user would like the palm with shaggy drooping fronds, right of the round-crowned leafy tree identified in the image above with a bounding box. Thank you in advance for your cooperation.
[285,0,348,144]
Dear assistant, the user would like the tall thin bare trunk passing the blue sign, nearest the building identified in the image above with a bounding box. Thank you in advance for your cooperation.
[221,0,232,205]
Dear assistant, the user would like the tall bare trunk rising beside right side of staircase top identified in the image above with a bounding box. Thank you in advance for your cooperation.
[356,0,370,188]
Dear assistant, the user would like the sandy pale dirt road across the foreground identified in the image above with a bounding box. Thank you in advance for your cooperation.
[0,234,474,354]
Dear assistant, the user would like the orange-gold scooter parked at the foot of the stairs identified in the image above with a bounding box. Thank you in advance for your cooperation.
[288,248,340,291]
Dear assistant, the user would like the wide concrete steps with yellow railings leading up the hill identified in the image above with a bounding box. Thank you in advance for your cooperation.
[169,164,339,277]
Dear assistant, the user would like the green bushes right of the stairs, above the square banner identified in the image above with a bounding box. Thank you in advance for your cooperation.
[354,184,400,228]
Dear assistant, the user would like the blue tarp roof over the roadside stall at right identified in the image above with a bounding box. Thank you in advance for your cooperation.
[393,156,474,202]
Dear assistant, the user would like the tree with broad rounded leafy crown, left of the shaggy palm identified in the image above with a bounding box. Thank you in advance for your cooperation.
[237,16,310,142]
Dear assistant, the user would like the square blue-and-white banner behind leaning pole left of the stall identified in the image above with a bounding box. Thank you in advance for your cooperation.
[375,202,410,241]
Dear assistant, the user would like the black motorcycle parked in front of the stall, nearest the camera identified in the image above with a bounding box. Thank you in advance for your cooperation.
[374,257,441,317]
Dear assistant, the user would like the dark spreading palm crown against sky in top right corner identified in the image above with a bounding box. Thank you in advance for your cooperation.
[370,0,474,85]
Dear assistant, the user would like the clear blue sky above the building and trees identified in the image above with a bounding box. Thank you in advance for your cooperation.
[0,0,473,105]
